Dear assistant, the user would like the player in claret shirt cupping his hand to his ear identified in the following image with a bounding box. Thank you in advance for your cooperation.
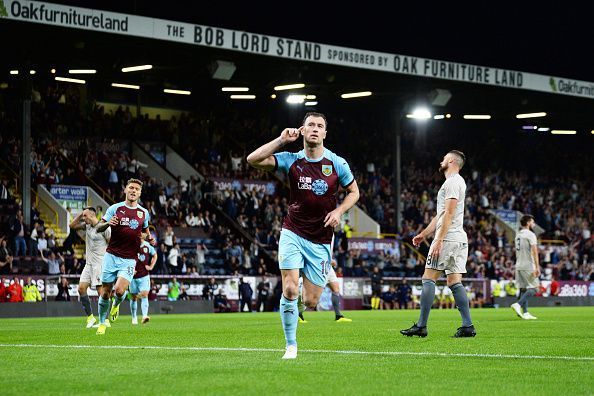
[247,113,359,359]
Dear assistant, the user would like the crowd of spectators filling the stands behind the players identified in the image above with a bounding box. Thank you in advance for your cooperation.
[0,79,594,280]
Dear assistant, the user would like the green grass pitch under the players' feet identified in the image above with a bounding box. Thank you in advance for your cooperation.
[0,307,594,395]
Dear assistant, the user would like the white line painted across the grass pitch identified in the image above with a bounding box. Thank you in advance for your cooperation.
[0,344,594,361]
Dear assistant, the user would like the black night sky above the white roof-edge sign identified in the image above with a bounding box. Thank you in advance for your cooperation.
[33,0,594,81]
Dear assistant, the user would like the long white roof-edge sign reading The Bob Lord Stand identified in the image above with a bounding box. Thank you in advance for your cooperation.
[0,0,594,99]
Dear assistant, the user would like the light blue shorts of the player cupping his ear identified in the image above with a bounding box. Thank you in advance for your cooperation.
[278,228,332,287]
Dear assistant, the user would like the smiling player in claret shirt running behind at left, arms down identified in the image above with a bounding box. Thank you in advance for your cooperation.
[97,179,153,335]
